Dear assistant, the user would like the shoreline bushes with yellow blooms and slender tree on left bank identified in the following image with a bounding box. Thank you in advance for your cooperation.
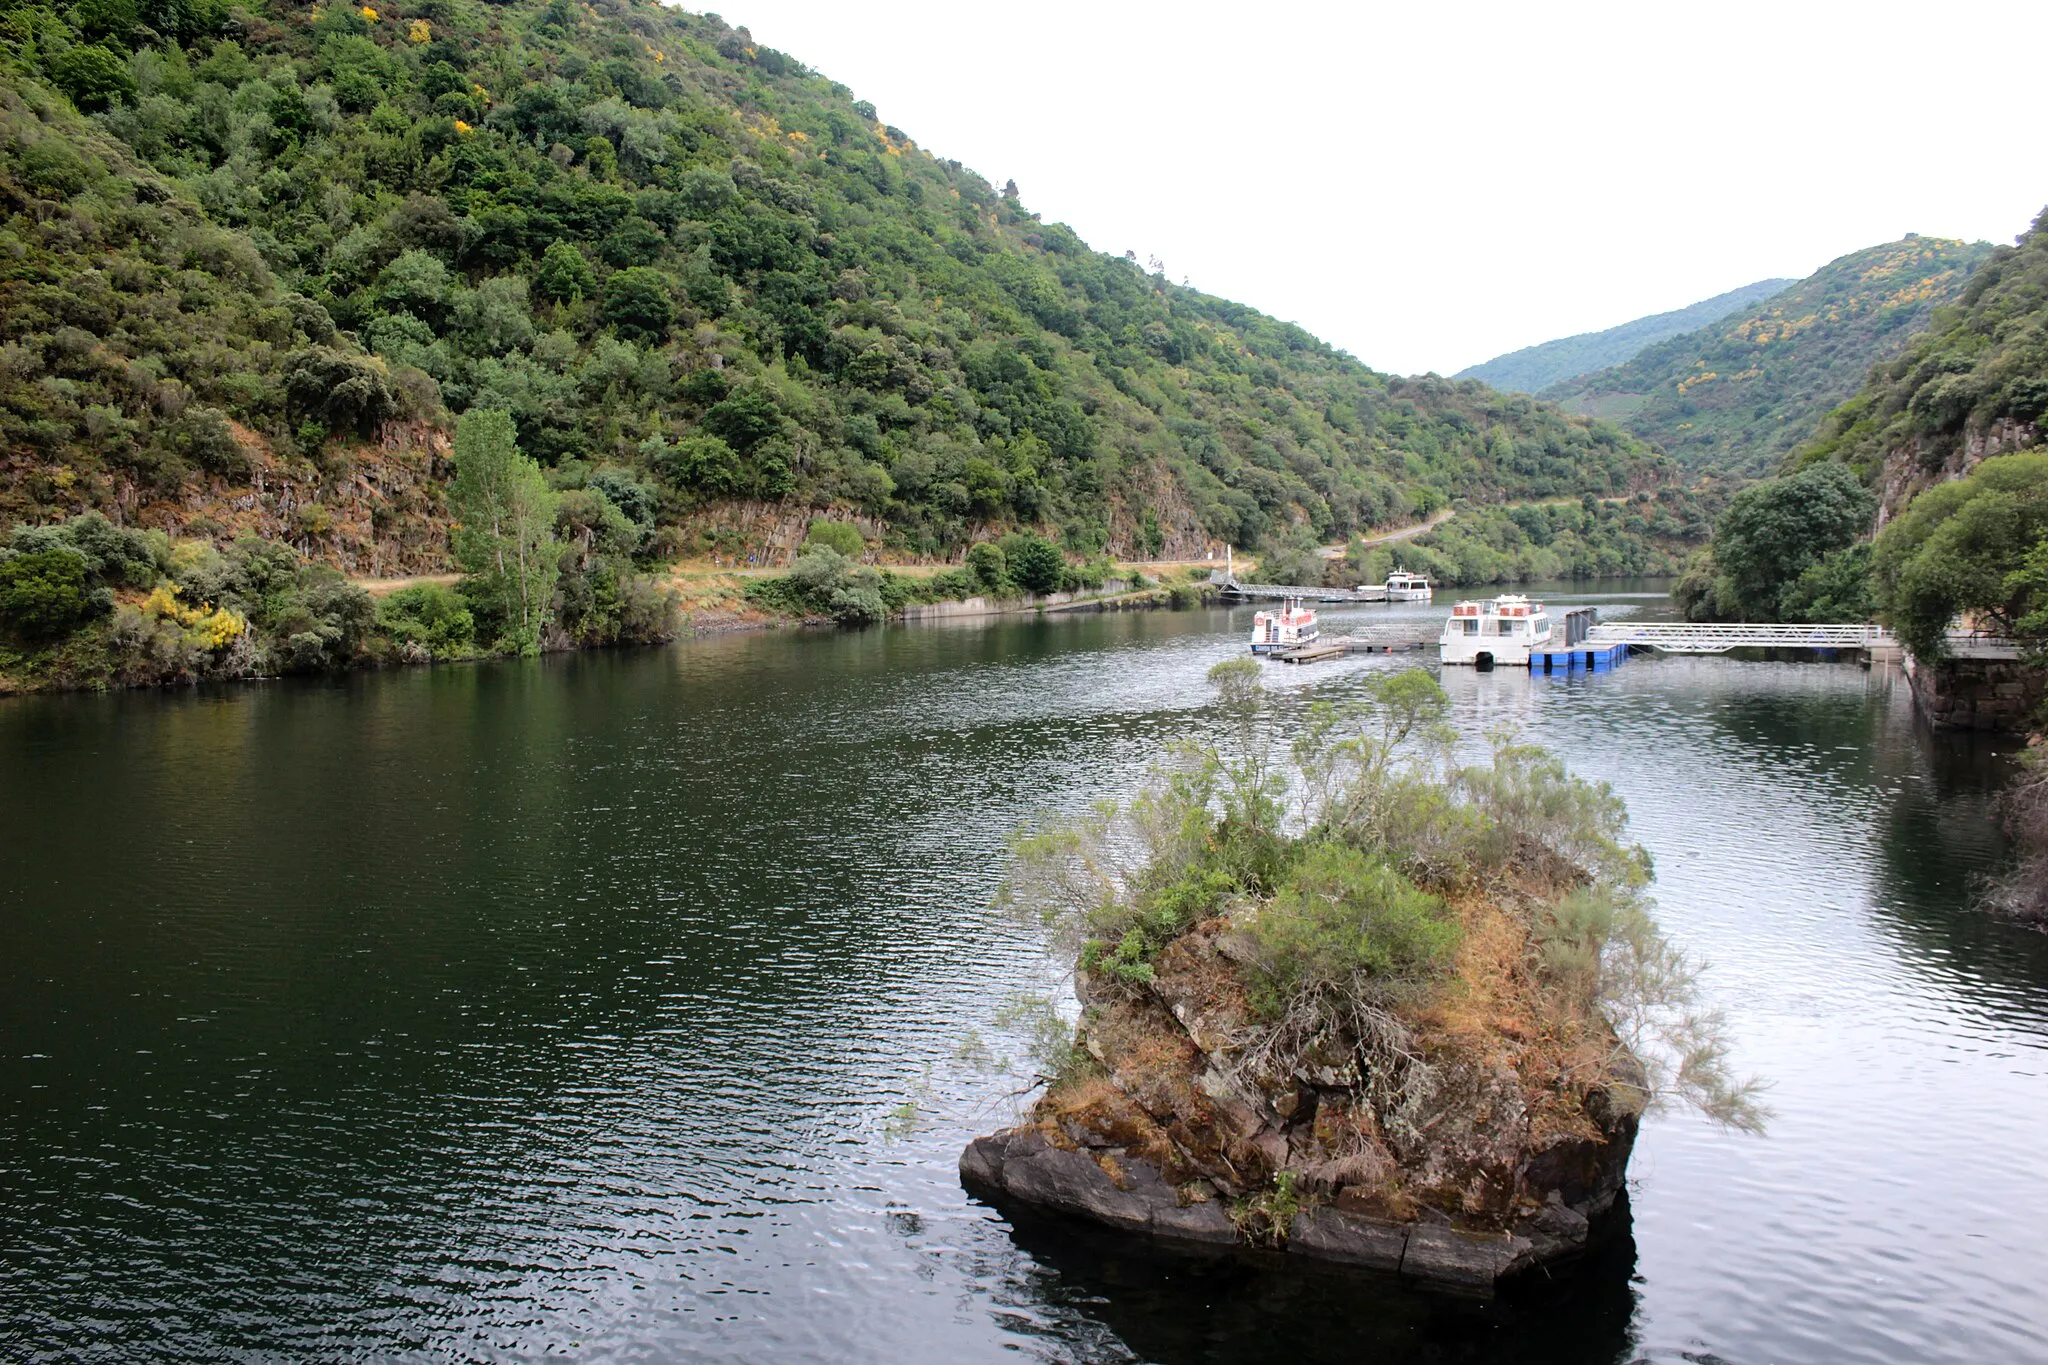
[0,411,678,686]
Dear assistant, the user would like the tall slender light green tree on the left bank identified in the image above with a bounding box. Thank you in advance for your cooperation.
[449,407,561,653]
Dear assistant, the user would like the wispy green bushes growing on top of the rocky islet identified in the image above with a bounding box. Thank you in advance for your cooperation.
[1004,659,1761,1126]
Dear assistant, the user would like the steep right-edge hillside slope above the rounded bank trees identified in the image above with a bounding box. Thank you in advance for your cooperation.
[1798,209,2048,524]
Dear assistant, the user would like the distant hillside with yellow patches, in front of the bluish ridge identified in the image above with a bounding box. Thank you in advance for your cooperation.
[1542,235,1991,473]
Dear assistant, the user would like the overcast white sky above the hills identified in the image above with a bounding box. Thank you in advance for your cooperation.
[688,0,2048,375]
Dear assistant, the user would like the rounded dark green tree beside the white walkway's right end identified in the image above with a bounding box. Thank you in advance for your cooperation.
[1714,465,1878,620]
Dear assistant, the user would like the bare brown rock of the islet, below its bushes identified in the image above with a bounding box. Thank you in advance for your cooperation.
[961,909,1636,1289]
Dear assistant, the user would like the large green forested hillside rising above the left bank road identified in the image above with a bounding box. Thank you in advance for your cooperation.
[0,0,1667,571]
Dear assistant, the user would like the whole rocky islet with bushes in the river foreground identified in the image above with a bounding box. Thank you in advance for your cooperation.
[961,661,1761,1291]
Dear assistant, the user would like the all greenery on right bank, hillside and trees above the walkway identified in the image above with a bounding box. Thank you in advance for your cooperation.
[1677,215,2048,659]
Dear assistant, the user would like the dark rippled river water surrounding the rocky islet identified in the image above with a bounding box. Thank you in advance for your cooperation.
[0,587,2048,1365]
